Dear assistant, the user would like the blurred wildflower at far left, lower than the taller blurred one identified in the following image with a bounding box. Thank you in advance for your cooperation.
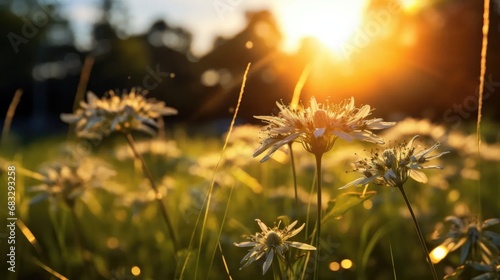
[29,158,116,206]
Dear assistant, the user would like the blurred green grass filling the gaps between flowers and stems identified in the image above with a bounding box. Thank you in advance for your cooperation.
[0,120,500,280]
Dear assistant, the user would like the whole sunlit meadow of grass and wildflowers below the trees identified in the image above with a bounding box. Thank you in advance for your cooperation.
[0,83,500,279]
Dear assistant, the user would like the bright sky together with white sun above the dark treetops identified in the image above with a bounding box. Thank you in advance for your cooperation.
[55,0,376,56]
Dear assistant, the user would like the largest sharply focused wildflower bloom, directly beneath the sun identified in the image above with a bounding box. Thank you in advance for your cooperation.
[254,97,395,162]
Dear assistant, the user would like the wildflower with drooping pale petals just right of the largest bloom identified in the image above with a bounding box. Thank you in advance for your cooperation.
[340,135,448,189]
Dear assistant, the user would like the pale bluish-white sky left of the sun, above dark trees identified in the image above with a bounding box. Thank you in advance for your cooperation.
[59,0,283,55]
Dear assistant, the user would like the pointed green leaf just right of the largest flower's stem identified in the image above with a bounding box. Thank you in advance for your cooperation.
[322,191,377,223]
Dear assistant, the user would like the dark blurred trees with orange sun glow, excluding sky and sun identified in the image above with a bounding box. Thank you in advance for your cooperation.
[0,0,500,140]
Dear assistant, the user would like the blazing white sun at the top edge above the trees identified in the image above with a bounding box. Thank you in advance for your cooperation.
[277,0,367,56]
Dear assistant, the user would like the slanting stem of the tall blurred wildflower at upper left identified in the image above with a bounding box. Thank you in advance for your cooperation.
[125,133,179,256]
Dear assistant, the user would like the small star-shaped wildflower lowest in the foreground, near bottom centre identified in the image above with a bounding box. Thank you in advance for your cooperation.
[234,219,316,275]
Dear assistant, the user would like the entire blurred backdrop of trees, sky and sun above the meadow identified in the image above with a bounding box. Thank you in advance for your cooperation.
[0,0,500,139]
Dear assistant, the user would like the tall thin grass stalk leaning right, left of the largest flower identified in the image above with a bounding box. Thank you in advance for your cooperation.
[193,63,251,279]
